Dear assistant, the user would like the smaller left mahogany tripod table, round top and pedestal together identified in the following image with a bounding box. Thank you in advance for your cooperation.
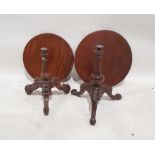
[23,33,74,115]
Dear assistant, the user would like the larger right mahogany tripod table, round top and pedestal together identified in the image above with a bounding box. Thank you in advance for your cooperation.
[71,30,132,125]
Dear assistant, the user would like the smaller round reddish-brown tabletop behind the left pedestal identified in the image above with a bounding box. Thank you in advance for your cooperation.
[23,33,74,81]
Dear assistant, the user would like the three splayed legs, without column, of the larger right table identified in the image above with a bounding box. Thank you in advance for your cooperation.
[71,83,122,125]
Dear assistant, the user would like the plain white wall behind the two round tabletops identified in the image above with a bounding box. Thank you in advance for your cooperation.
[0,15,155,77]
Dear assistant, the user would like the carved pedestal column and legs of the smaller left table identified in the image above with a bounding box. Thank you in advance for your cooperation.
[25,48,70,115]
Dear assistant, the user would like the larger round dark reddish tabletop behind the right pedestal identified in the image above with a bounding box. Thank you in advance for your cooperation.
[75,30,132,86]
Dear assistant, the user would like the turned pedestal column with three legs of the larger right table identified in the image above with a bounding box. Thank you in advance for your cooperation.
[71,45,122,125]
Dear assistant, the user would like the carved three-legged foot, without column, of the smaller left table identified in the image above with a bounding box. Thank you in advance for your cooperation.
[25,74,70,115]
